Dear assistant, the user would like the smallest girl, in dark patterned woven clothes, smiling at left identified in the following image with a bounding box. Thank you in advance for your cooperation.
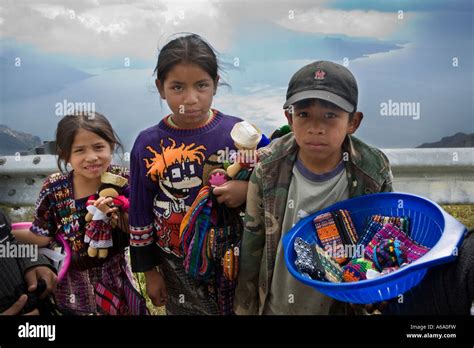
[17,113,129,314]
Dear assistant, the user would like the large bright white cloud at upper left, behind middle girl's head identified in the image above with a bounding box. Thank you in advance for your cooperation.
[0,0,234,60]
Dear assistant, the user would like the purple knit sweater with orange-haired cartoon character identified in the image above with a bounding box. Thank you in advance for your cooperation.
[129,110,241,272]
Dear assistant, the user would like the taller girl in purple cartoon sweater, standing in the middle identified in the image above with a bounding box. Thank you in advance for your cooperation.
[130,34,247,314]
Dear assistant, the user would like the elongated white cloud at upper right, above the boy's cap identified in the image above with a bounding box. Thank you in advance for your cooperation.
[278,7,407,39]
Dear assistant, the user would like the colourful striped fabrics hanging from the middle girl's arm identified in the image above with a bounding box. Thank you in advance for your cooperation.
[180,186,242,315]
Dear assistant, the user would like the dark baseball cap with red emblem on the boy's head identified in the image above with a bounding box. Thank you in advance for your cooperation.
[283,60,358,113]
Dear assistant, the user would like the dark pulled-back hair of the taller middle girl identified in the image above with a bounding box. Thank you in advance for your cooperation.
[155,34,220,84]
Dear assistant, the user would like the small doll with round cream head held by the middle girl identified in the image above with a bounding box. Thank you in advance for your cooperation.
[227,121,262,179]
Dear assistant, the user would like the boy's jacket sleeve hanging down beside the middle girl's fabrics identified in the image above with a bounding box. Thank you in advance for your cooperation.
[234,165,270,315]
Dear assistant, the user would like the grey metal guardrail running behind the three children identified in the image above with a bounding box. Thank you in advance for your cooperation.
[0,148,474,206]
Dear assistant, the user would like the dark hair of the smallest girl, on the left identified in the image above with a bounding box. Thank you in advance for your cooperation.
[56,112,123,172]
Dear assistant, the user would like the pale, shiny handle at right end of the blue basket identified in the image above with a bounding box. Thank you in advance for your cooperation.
[407,210,467,269]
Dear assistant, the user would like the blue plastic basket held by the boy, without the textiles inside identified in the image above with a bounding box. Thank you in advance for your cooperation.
[283,193,466,303]
